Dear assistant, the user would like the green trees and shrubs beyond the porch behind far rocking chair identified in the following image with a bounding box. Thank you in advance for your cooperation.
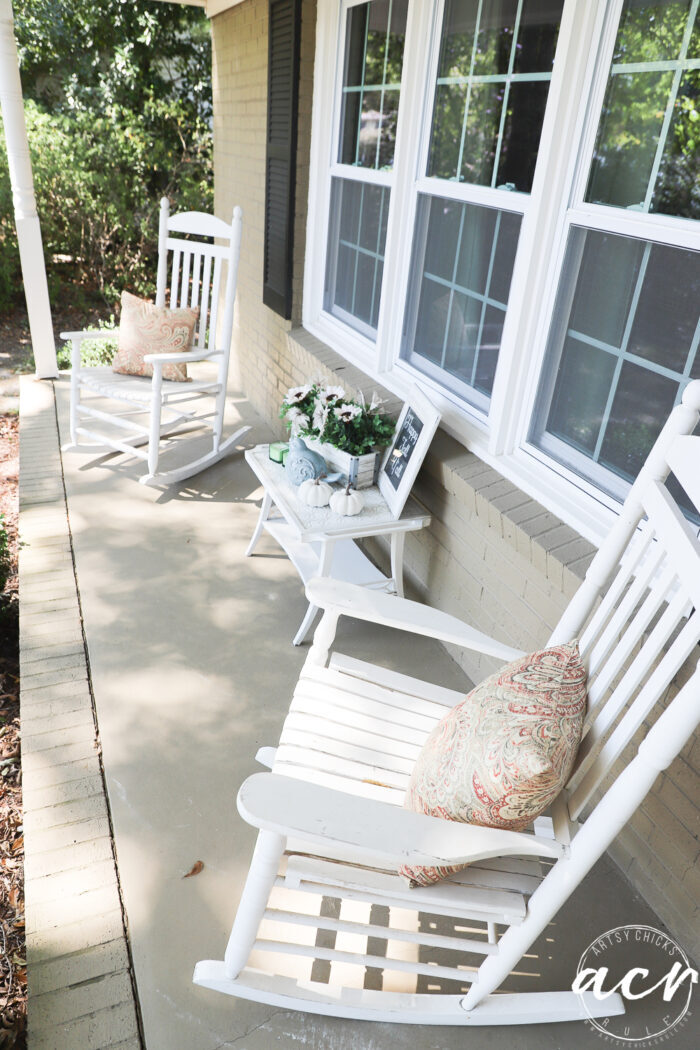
[0,0,212,309]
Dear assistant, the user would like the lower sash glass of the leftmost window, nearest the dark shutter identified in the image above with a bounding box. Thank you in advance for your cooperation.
[323,179,389,336]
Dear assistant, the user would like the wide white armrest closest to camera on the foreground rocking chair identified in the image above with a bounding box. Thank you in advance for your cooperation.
[237,773,569,867]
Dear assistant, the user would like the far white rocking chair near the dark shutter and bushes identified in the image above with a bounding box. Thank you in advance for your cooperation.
[61,197,250,485]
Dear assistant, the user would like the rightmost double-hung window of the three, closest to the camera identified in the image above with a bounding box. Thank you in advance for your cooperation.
[530,0,700,497]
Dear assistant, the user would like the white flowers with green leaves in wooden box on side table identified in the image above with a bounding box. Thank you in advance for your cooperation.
[279,383,395,456]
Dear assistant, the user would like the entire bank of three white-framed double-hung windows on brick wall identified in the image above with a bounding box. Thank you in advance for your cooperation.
[304,0,700,538]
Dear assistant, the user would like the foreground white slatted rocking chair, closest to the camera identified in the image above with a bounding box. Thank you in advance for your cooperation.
[194,381,700,1025]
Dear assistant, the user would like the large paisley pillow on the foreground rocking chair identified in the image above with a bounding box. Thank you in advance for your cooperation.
[400,642,587,886]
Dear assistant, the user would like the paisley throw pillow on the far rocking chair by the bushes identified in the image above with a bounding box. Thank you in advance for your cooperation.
[112,292,199,383]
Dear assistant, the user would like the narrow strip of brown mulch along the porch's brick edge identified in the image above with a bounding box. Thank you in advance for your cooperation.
[0,415,26,1050]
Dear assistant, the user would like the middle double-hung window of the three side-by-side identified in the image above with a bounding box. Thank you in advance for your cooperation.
[401,0,564,413]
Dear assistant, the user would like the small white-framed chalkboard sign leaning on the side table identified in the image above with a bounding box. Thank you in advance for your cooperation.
[379,387,440,518]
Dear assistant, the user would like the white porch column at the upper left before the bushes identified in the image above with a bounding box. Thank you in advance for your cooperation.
[0,0,59,379]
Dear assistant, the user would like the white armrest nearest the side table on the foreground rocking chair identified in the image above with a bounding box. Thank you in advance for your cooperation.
[306,576,524,660]
